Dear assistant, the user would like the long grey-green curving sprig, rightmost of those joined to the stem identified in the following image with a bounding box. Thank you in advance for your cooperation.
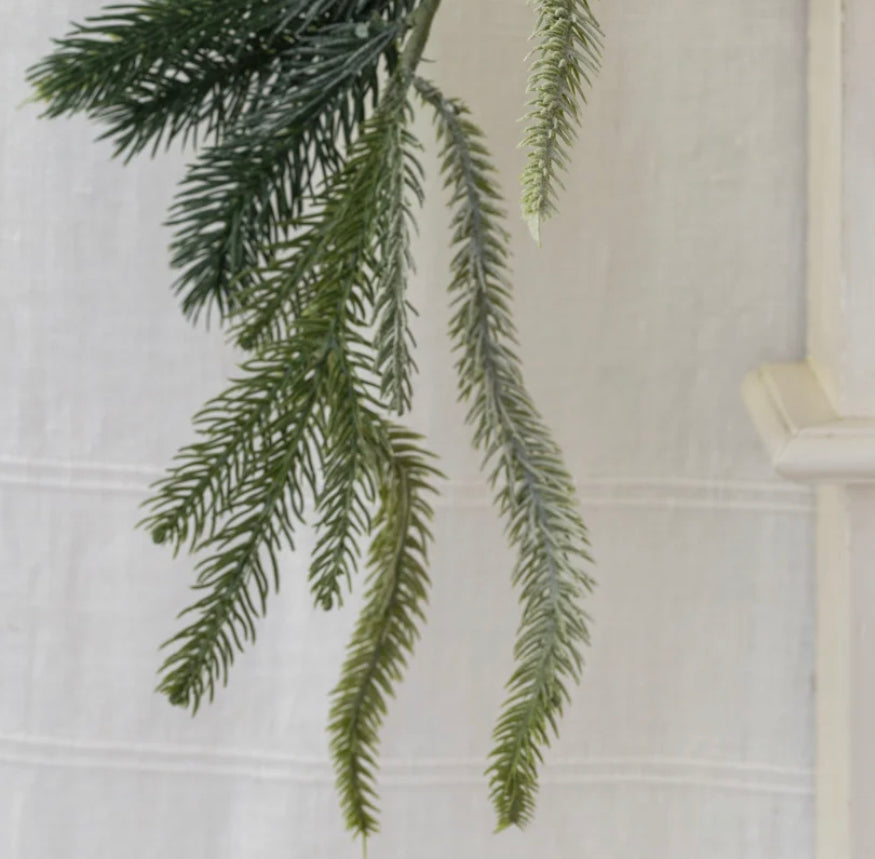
[417,81,593,828]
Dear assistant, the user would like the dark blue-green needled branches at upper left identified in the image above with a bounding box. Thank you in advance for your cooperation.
[29,0,432,317]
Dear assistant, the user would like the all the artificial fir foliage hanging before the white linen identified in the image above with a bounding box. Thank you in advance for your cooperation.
[30,0,601,848]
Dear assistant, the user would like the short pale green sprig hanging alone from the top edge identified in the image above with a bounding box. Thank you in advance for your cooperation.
[522,0,602,242]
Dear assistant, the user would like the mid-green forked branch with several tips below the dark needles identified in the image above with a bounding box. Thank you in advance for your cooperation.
[145,84,420,709]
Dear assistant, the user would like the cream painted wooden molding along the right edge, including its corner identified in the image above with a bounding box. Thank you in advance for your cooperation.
[743,0,875,859]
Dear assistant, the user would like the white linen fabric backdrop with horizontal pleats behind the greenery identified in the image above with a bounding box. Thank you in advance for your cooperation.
[0,0,813,859]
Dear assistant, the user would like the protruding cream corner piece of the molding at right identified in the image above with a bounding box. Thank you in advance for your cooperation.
[742,362,875,483]
